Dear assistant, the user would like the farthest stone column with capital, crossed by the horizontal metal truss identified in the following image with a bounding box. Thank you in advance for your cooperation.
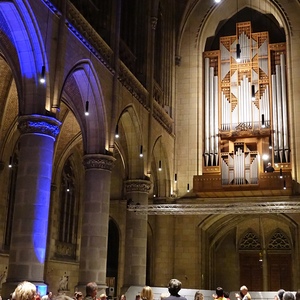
[124,180,150,287]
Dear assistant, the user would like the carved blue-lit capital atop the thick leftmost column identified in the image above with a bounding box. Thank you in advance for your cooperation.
[18,115,61,138]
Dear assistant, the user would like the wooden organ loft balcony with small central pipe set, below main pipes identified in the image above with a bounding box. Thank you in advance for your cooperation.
[193,123,293,198]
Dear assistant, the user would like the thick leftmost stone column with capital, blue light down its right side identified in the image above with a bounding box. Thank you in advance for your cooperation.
[3,115,61,297]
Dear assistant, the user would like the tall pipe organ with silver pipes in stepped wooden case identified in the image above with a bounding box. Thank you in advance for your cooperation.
[203,22,290,185]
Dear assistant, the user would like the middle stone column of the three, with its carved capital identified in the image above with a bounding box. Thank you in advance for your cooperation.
[77,154,115,293]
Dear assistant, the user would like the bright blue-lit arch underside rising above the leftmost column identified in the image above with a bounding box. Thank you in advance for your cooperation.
[0,0,48,114]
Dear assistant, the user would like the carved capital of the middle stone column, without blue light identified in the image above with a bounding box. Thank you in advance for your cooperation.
[83,154,116,171]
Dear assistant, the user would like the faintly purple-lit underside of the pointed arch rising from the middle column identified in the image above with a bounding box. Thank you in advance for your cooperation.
[62,60,108,154]
